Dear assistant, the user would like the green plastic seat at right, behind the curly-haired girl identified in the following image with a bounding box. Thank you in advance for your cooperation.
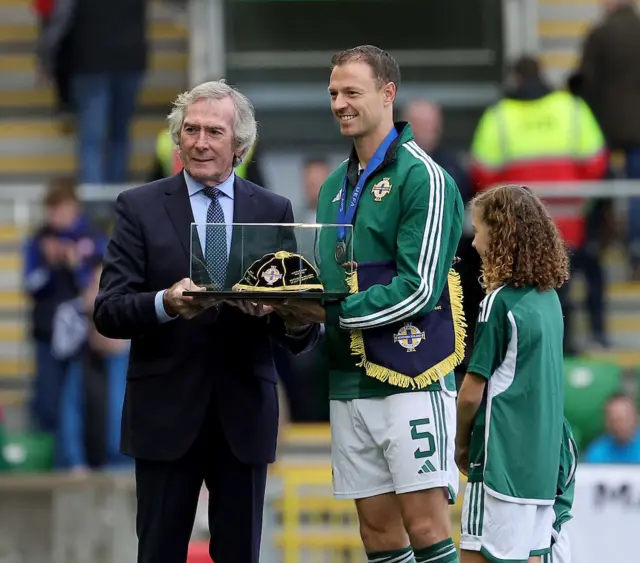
[564,358,622,451]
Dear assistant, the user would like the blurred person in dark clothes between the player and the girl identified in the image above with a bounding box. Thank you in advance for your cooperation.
[405,100,478,387]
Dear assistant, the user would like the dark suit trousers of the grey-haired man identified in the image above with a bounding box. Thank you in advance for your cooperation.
[136,400,267,563]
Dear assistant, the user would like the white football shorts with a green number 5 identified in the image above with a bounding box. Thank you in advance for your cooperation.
[330,390,459,502]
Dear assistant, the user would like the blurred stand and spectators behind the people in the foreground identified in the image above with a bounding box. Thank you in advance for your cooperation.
[0,0,640,560]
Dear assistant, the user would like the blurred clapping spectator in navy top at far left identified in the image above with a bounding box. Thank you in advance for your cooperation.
[24,180,106,433]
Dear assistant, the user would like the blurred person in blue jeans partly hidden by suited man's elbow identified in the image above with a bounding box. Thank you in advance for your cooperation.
[52,263,132,472]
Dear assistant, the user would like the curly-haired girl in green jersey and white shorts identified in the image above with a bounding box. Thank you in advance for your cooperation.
[456,186,568,563]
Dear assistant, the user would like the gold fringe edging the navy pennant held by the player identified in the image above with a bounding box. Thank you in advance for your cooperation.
[347,269,467,389]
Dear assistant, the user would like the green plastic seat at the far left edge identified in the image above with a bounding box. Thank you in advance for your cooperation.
[2,432,54,473]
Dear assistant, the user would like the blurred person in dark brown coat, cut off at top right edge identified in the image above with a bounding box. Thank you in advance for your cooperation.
[576,0,640,280]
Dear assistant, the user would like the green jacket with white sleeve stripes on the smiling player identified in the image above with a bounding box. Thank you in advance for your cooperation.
[317,123,464,399]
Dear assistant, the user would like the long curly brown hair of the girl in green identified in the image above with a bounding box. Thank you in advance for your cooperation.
[473,185,569,291]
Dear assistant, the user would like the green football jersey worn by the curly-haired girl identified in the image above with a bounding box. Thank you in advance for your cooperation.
[467,286,564,505]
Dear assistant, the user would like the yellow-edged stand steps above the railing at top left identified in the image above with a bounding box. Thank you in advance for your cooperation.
[0,0,188,184]
